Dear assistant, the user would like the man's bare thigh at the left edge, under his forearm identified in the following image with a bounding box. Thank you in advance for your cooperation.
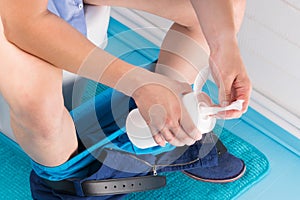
[0,18,62,108]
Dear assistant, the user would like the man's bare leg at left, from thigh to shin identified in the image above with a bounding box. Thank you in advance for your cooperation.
[0,18,77,166]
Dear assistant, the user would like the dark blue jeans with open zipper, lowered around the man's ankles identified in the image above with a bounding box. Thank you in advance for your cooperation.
[30,133,218,200]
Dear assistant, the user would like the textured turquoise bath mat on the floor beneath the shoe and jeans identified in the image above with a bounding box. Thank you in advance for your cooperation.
[0,123,269,200]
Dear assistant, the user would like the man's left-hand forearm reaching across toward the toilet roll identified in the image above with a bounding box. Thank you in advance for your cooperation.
[2,1,141,90]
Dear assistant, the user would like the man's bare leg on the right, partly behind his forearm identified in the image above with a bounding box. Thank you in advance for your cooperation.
[85,0,246,83]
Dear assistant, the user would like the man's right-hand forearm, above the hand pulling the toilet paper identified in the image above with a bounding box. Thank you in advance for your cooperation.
[191,0,236,50]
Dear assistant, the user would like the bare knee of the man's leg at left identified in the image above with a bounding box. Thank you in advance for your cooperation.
[10,87,65,138]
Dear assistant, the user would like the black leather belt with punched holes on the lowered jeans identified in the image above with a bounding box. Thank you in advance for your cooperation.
[44,176,166,196]
